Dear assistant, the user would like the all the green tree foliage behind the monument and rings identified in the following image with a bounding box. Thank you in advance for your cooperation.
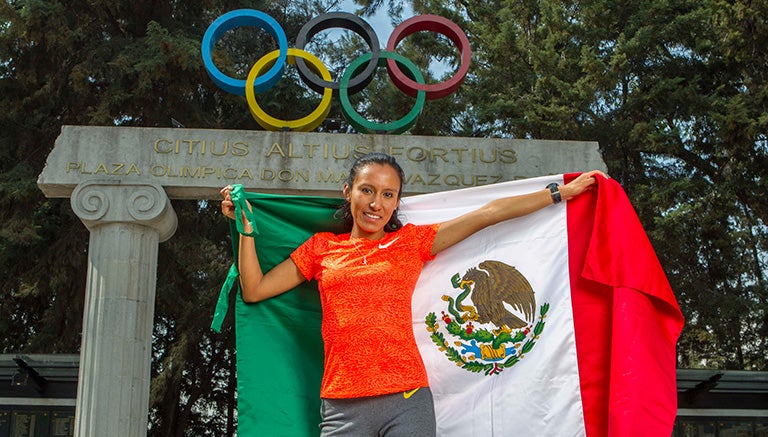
[0,0,768,435]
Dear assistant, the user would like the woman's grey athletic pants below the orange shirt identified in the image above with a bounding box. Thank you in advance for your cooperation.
[320,387,436,437]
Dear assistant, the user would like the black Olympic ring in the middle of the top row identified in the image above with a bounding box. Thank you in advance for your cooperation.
[296,12,380,95]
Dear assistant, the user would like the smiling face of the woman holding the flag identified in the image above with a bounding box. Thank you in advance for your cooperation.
[344,163,400,240]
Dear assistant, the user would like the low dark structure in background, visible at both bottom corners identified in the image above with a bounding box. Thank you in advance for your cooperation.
[0,354,768,437]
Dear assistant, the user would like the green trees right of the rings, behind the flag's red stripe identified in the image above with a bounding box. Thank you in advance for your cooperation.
[400,0,768,370]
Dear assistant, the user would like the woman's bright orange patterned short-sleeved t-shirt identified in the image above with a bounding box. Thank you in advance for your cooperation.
[291,224,438,398]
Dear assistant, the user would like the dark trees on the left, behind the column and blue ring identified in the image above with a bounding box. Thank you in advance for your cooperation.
[0,0,346,435]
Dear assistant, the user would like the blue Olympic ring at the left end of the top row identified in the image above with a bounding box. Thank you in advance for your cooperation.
[201,9,288,96]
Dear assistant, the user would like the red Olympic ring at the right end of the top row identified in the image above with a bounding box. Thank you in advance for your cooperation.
[387,15,472,100]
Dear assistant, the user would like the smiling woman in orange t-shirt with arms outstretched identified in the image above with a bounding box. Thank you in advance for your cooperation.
[221,153,607,436]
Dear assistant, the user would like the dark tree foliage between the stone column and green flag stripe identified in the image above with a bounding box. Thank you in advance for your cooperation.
[150,201,235,435]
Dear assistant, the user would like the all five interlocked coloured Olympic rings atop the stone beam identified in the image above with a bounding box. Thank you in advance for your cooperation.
[202,9,471,133]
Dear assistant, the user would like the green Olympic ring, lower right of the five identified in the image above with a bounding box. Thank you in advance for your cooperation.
[339,50,427,134]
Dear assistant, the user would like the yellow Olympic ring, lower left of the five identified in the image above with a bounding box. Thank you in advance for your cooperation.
[245,48,333,132]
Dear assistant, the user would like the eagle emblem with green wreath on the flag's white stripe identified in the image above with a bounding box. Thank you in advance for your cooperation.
[425,261,549,375]
